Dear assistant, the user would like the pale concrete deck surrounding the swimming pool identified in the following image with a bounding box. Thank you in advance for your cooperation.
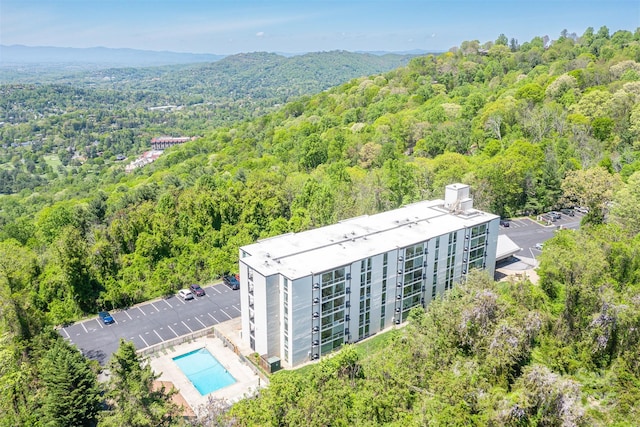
[148,319,265,420]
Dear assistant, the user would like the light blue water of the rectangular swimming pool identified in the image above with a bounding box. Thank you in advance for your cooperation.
[173,348,236,396]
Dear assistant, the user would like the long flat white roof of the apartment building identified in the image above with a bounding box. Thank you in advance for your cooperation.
[241,199,498,280]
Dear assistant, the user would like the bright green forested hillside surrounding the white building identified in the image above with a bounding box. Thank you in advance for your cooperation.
[0,27,640,426]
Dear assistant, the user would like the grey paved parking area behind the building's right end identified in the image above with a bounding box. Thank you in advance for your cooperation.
[500,212,584,258]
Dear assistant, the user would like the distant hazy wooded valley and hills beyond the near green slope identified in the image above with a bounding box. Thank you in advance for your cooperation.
[0,51,411,194]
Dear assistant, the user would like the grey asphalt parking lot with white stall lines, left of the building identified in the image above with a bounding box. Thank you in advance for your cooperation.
[59,284,240,365]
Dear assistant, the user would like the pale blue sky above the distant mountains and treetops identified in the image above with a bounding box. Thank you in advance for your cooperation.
[0,0,640,55]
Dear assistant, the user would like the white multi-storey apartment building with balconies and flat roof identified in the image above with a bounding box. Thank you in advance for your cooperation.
[239,184,499,368]
